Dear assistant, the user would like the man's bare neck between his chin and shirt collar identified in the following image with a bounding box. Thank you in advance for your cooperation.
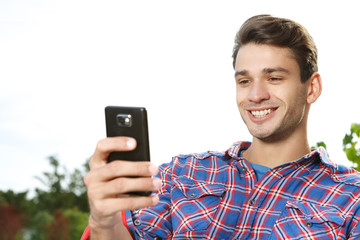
[243,132,310,168]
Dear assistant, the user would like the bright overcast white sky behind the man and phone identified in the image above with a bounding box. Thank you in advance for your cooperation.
[0,0,360,194]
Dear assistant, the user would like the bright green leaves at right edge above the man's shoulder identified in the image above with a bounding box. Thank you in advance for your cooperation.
[343,123,360,171]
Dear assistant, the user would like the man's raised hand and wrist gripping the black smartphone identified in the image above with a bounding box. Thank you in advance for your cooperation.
[84,137,161,239]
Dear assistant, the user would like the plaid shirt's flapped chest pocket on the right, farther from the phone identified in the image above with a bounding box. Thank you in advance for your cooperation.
[270,201,345,240]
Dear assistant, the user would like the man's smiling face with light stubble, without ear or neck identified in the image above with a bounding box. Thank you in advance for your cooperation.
[235,44,307,141]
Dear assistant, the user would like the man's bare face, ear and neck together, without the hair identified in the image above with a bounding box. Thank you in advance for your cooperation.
[235,43,321,167]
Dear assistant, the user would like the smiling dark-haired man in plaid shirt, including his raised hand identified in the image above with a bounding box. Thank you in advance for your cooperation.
[84,15,360,239]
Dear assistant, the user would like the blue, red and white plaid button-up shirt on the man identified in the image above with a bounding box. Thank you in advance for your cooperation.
[124,142,360,240]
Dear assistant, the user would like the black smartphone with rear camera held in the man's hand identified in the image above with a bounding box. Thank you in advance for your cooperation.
[105,106,151,196]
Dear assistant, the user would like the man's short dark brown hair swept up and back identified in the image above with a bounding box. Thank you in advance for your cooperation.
[232,15,318,82]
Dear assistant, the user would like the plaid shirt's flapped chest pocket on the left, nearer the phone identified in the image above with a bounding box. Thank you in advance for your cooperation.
[170,177,225,233]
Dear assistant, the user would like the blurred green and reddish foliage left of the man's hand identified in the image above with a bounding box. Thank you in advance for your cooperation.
[0,156,89,240]
